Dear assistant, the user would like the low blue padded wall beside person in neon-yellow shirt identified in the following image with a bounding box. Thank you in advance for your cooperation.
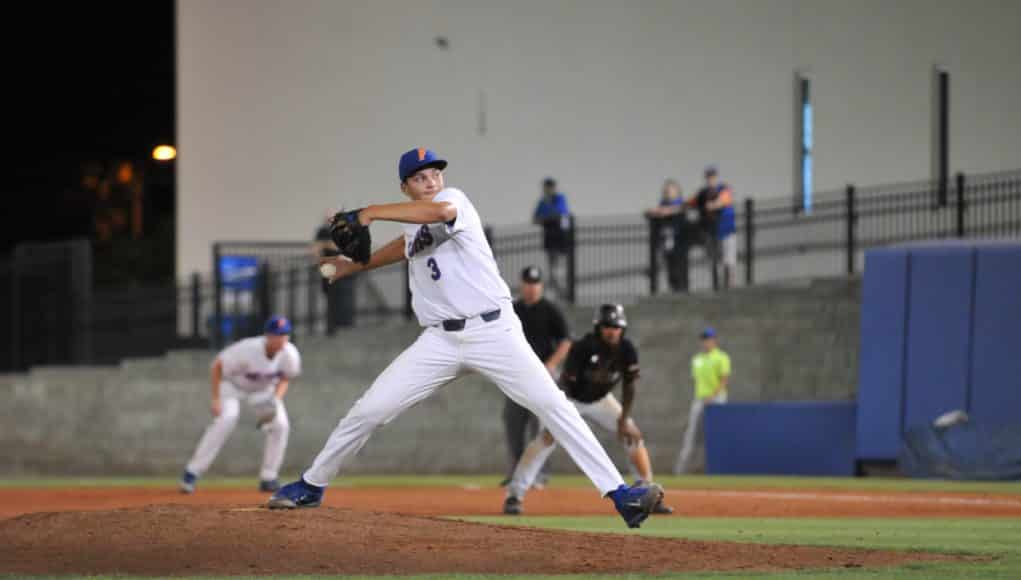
[706,401,858,476]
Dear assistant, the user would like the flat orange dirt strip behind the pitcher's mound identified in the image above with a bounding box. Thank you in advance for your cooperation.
[0,487,1021,518]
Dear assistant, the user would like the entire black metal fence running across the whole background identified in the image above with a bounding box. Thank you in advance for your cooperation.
[0,171,1021,369]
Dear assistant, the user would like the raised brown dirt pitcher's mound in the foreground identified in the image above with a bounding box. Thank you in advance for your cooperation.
[0,505,953,576]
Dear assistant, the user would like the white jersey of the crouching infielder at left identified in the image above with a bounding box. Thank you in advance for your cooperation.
[216,336,301,393]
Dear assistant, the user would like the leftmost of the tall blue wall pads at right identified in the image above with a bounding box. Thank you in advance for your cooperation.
[857,248,909,461]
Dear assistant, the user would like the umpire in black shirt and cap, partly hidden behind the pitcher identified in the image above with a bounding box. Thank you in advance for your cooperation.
[502,265,571,485]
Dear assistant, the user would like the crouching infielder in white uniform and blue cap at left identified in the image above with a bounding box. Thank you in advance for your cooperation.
[179,317,301,493]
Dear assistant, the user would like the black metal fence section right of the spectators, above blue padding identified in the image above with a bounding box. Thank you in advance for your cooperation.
[738,171,1021,284]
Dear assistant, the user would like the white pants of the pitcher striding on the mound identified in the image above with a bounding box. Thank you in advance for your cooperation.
[303,306,624,494]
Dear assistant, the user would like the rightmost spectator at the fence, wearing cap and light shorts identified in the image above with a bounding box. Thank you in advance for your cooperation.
[688,165,737,288]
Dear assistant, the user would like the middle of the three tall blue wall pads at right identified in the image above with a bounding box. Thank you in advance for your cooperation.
[903,245,975,430]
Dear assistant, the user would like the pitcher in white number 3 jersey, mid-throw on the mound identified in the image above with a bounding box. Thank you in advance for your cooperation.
[269,148,663,528]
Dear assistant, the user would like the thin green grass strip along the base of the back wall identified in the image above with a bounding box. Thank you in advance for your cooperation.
[0,474,1021,494]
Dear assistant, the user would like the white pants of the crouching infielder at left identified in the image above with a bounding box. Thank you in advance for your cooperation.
[185,381,291,480]
